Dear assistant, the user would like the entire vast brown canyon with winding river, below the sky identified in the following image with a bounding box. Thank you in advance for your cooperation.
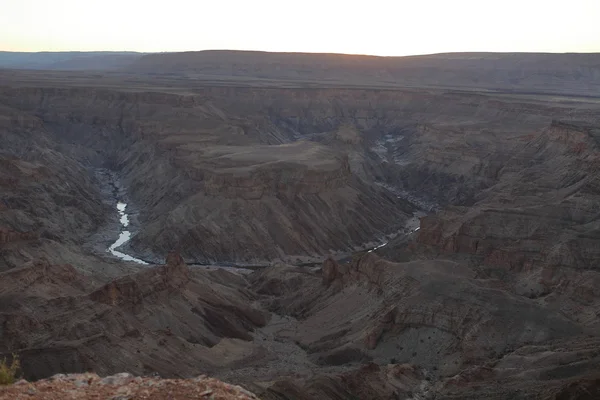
[0,52,600,400]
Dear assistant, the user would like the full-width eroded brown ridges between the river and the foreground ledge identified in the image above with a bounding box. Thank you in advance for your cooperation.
[0,253,600,399]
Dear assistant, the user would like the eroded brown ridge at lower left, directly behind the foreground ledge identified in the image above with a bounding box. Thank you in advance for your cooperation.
[0,252,266,379]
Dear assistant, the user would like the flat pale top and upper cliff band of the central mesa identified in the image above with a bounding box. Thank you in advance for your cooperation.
[204,143,351,200]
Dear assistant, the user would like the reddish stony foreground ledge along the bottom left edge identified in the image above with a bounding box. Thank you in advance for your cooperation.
[0,373,258,400]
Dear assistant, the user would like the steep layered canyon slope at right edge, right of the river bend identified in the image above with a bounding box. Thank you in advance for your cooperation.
[418,122,600,325]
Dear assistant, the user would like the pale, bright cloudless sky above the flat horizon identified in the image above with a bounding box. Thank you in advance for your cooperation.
[0,0,600,56]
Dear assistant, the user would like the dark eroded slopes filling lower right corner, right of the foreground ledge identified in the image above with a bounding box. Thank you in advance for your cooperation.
[250,254,600,400]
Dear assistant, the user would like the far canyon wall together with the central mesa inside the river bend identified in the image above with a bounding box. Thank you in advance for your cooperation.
[1,81,596,262]
